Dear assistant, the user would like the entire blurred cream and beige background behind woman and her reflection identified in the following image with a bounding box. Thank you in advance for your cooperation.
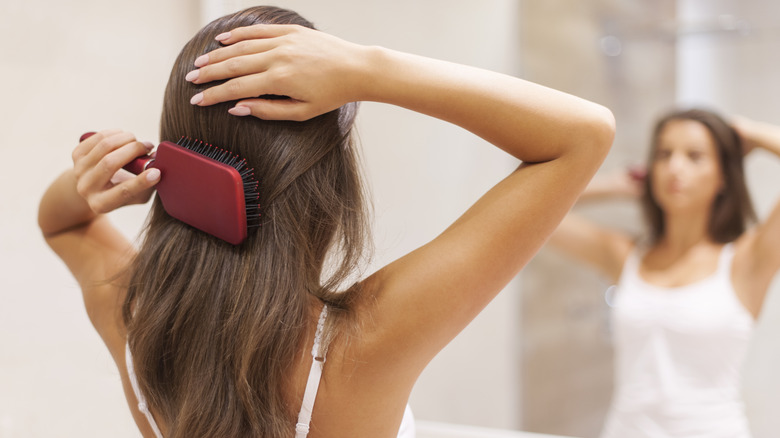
[0,0,780,438]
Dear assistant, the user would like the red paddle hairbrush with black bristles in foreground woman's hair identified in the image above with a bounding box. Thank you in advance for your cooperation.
[81,132,260,245]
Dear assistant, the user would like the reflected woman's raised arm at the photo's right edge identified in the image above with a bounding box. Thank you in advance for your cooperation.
[734,117,780,316]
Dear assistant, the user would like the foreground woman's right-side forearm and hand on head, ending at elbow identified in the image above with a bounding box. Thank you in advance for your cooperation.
[187,25,613,162]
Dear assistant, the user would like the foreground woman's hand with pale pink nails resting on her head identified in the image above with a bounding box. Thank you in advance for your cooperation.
[186,25,363,121]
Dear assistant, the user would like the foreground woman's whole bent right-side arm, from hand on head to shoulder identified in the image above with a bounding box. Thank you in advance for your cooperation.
[188,26,614,381]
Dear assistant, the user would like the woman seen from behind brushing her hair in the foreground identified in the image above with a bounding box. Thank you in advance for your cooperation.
[39,7,614,438]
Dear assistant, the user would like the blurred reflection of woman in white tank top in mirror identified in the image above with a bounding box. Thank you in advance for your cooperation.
[551,109,780,438]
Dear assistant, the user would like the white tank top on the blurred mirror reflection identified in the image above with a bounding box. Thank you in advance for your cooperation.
[602,244,754,438]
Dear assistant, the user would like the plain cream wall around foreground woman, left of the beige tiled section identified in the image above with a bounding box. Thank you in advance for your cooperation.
[0,0,519,438]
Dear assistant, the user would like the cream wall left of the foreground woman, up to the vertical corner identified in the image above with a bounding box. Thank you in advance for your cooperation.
[0,0,192,438]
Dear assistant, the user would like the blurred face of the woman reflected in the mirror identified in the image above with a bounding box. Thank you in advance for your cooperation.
[651,120,723,213]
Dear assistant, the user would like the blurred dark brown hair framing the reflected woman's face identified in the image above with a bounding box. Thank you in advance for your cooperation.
[641,108,756,243]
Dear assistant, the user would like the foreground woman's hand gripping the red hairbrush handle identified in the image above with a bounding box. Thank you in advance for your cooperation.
[72,130,160,214]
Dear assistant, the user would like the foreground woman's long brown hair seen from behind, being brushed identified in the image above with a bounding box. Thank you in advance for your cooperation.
[123,7,367,438]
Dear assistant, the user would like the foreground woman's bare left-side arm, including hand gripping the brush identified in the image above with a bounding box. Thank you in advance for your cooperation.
[38,131,156,360]
